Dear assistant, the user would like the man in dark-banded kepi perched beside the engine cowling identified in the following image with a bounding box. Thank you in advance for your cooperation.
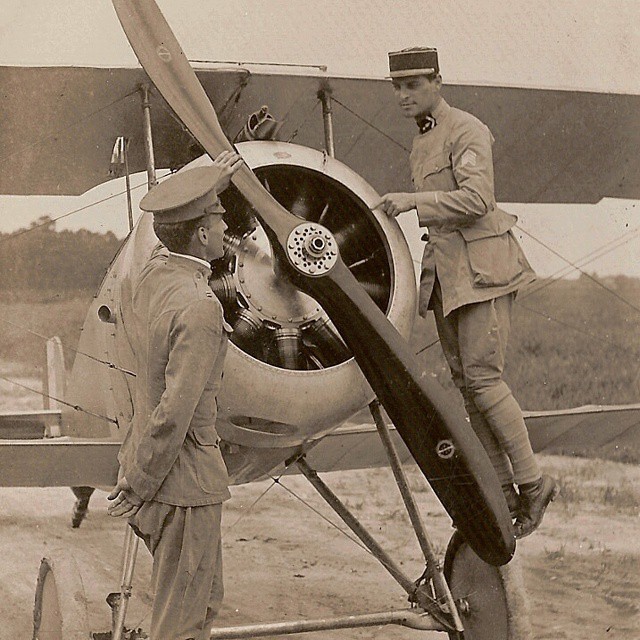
[380,48,558,537]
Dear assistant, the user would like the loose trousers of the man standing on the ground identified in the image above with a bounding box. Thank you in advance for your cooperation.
[130,502,223,640]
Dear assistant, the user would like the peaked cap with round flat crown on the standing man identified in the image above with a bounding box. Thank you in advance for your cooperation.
[140,167,226,222]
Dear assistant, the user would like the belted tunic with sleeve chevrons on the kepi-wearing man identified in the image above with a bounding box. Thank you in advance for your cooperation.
[410,99,535,316]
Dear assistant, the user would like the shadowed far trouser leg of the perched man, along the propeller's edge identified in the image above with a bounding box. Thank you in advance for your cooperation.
[432,280,513,486]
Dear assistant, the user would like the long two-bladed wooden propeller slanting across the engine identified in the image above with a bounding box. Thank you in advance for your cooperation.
[113,0,515,565]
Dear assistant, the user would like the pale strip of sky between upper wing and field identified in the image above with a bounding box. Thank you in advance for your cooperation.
[0,170,640,278]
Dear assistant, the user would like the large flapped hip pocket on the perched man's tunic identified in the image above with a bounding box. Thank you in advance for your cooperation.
[467,232,524,287]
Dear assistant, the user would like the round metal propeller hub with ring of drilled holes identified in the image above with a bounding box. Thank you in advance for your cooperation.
[287,222,339,276]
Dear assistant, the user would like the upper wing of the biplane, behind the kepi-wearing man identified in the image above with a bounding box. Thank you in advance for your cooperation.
[0,65,640,203]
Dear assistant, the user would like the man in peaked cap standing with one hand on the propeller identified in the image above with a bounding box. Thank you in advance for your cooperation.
[109,151,241,640]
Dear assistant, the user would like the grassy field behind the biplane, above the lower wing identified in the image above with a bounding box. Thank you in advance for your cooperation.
[0,276,640,410]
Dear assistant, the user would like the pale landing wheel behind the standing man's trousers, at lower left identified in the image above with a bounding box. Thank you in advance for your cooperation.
[33,554,91,640]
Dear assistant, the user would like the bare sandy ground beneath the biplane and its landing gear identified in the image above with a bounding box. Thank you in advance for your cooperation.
[0,457,640,640]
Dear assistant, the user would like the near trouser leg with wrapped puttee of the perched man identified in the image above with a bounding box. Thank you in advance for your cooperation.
[457,294,540,485]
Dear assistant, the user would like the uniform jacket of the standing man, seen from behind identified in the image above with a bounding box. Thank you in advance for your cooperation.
[119,250,229,507]
